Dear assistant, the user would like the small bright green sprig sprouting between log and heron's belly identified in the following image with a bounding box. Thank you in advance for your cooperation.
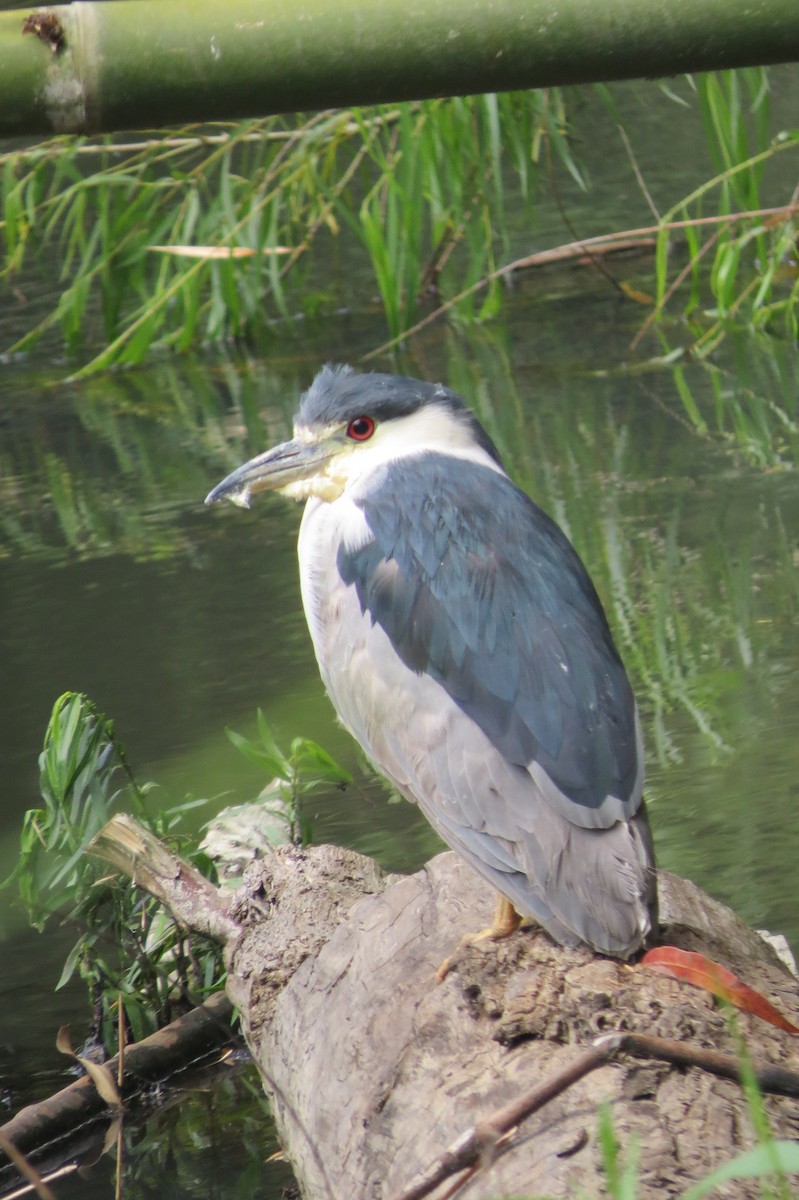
[224,709,353,846]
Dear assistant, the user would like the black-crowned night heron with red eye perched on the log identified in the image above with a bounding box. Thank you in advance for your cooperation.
[208,367,656,958]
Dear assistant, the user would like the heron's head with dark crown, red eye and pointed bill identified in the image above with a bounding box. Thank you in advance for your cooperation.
[205,357,499,506]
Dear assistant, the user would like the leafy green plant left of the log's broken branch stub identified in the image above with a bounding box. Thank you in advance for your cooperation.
[4,692,223,1046]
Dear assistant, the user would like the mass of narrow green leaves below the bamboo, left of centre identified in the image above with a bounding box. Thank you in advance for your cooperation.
[0,92,566,373]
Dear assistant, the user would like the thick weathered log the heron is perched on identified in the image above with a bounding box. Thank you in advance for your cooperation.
[76,817,799,1200]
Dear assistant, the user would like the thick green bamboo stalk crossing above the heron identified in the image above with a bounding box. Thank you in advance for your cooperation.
[0,0,799,137]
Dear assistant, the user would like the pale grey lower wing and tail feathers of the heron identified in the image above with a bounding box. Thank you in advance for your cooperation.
[324,581,656,956]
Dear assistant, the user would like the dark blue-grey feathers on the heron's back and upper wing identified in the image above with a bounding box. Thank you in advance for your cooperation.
[338,454,643,828]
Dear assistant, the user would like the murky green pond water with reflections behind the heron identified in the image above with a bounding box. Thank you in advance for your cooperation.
[0,77,799,1195]
